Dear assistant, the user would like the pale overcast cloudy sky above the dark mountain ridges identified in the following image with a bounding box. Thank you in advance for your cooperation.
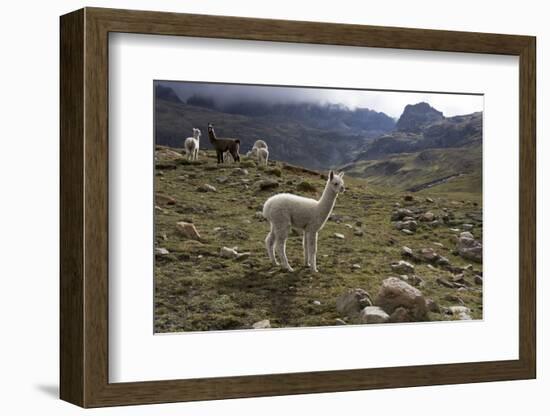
[160,81,483,119]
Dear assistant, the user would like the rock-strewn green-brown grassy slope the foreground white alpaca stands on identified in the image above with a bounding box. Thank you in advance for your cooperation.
[155,148,482,332]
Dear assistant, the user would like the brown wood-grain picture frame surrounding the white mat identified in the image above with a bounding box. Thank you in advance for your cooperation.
[60,8,536,407]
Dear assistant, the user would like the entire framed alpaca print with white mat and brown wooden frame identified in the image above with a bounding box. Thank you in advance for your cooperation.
[60,8,536,407]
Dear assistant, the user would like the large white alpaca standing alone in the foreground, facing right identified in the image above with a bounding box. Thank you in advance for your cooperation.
[263,171,345,272]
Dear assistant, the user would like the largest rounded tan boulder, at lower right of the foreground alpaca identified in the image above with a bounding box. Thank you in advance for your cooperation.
[374,277,428,321]
